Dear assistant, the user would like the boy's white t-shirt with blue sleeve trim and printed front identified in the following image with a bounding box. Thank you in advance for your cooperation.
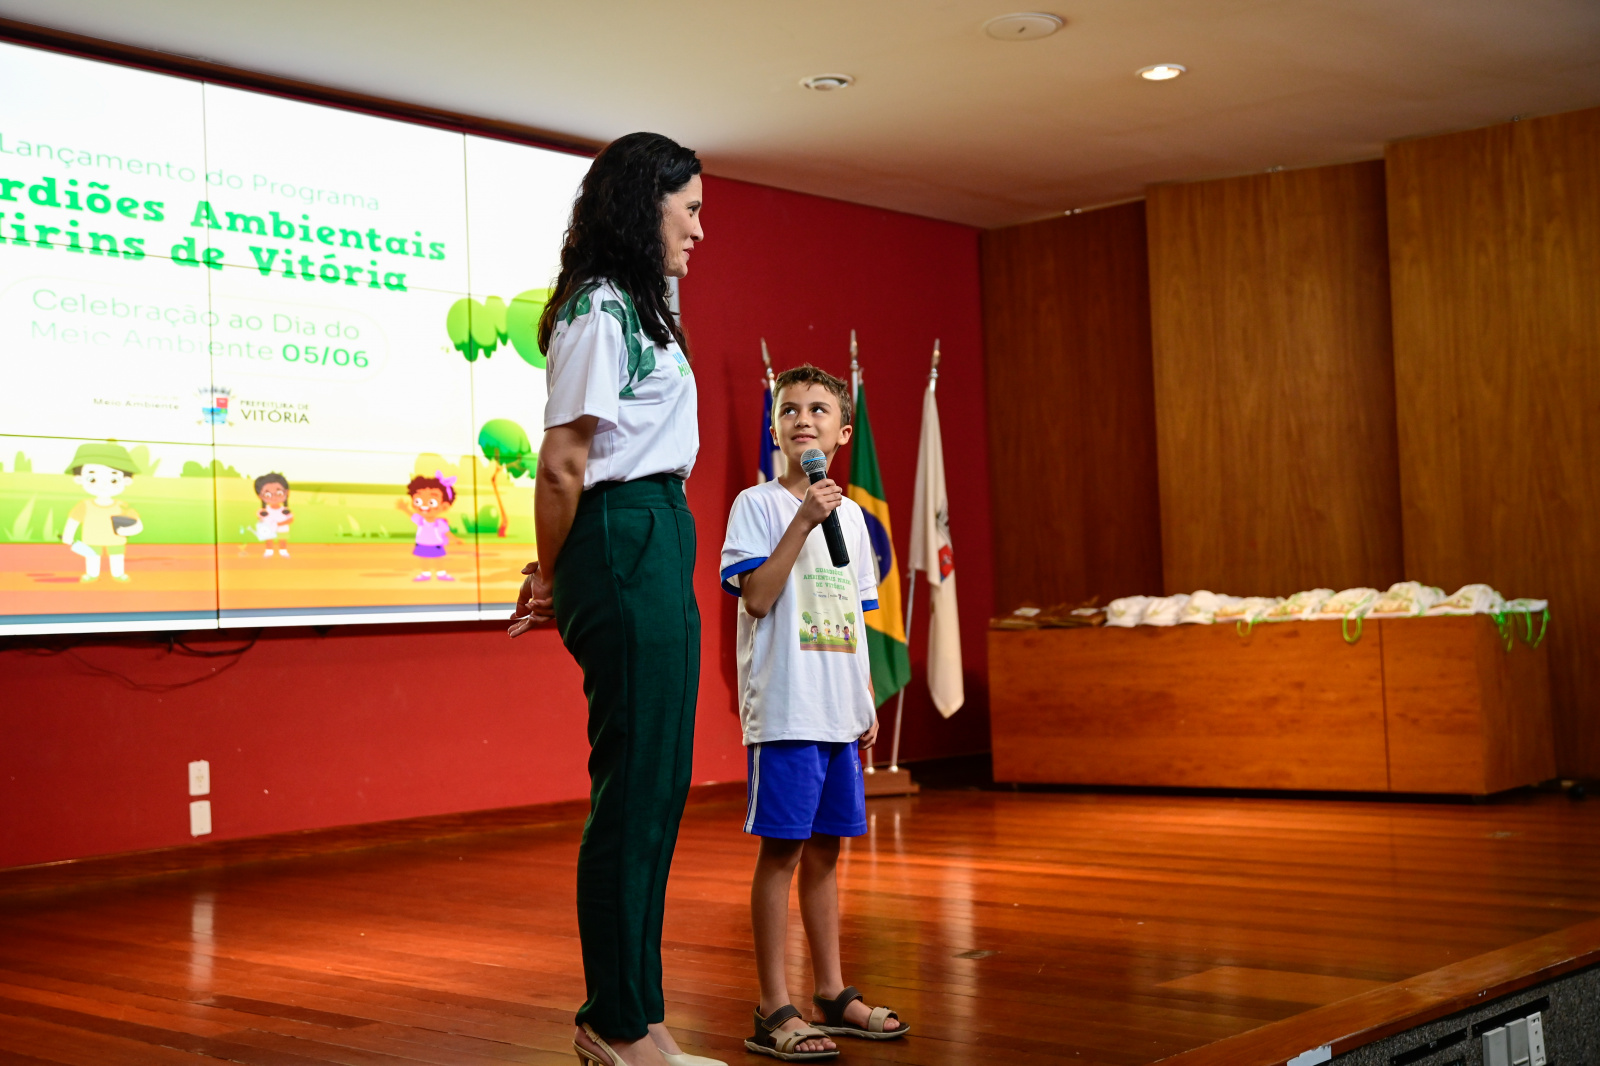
[722,482,878,744]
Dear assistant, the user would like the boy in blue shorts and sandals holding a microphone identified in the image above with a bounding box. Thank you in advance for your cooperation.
[722,365,909,1061]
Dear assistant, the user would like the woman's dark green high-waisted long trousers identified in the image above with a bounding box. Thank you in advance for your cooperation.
[554,475,699,1040]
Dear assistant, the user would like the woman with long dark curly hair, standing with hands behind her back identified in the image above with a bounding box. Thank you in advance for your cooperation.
[510,133,722,1066]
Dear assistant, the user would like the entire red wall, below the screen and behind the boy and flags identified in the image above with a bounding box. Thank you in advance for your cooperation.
[0,178,992,868]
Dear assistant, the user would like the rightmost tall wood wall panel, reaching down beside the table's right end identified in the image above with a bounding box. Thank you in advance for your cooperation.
[1387,109,1600,778]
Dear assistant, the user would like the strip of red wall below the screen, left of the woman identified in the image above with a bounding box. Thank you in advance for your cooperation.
[0,624,604,866]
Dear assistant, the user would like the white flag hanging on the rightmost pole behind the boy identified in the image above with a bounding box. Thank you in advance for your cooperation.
[910,372,966,717]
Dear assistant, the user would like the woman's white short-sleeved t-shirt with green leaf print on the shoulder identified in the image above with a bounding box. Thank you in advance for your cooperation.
[544,282,699,488]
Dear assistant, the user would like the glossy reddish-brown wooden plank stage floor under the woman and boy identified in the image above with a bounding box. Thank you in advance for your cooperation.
[0,791,1600,1066]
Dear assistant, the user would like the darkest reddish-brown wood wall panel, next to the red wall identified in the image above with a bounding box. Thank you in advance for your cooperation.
[982,203,1162,611]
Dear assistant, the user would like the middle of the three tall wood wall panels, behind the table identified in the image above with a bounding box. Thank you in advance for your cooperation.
[1147,162,1402,595]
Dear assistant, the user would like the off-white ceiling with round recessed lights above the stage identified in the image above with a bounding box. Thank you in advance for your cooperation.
[0,0,1600,226]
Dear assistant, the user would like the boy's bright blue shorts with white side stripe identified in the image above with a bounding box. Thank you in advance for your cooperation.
[744,741,867,840]
